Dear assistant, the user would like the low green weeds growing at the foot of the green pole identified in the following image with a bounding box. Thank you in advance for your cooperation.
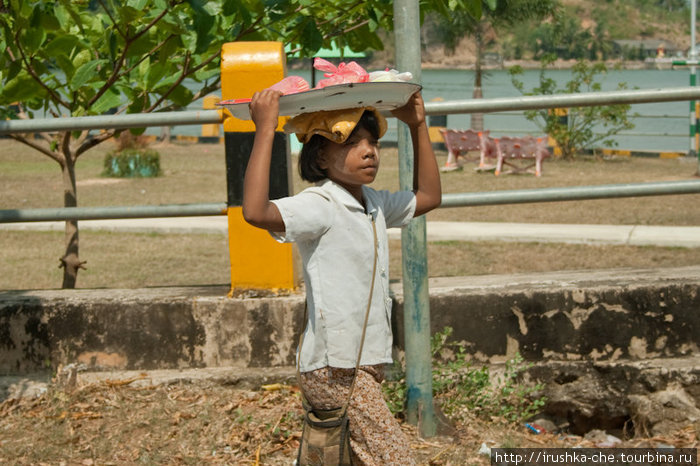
[384,327,545,422]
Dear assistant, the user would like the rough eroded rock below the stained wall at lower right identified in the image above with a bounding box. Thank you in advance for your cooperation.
[528,355,700,441]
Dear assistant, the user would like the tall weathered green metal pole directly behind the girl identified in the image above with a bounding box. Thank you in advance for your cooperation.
[394,0,437,438]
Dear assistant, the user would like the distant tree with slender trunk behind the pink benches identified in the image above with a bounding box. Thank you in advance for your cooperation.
[438,0,556,130]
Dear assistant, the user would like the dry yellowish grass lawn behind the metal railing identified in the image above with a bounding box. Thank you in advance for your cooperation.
[0,139,700,289]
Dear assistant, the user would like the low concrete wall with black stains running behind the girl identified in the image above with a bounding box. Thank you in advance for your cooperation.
[0,267,700,374]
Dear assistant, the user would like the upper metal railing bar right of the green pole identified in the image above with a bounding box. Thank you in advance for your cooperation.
[425,86,700,115]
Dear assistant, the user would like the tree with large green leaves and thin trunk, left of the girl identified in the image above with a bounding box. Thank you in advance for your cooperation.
[0,0,442,288]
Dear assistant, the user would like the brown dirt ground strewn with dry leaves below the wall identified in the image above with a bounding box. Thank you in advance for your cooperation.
[0,373,698,465]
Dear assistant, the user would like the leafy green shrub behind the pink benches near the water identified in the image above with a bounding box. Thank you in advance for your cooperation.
[510,55,634,160]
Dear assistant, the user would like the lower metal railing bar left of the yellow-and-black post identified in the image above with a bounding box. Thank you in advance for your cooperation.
[0,202,227,223]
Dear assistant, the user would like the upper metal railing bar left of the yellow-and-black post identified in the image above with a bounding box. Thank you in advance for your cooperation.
[0,110,224,134]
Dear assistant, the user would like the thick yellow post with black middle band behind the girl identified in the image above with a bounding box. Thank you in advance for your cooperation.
[221,42,299,293]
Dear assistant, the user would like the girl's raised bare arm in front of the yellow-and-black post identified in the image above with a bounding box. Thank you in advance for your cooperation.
[243,90,285,232]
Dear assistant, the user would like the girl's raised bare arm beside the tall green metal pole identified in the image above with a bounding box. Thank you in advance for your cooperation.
[392,92,442,217]
